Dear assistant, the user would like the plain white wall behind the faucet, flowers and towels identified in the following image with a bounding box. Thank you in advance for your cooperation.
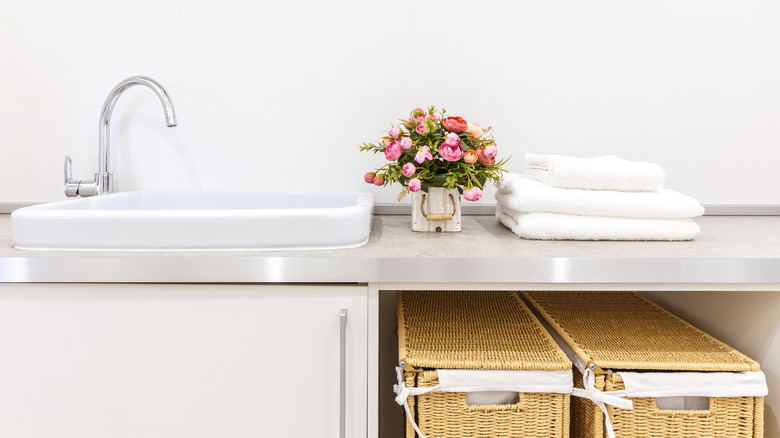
[0,0,780,204]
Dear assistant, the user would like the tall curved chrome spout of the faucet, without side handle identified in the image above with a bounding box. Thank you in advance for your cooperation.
[95,76,177,194]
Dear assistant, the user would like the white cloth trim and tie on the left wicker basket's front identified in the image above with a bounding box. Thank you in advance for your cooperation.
[393,367,572,438]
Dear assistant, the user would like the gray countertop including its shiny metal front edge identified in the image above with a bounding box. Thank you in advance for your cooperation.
[0,215,780,288]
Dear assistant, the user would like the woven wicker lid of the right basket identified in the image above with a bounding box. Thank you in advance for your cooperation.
[523,291,759,371]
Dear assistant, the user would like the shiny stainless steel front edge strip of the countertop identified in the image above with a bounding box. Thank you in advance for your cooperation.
[0,256,780,285]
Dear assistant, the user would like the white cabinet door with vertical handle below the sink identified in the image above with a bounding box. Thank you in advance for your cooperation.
[0,284,368,438]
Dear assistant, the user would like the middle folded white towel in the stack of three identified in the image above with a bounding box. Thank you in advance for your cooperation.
[496,174,704,219]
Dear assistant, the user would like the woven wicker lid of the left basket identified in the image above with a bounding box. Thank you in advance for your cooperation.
[398,291,571,370]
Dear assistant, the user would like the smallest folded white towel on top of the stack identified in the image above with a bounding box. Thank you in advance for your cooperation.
[525,154,666,192]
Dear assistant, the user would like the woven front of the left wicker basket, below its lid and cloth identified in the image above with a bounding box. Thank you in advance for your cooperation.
[405,371,569,438]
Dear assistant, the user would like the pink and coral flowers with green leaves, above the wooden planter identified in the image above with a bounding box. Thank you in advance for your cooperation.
[360,106,507,201]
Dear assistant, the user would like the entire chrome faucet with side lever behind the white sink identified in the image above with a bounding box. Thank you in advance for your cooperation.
[65,76,176,197]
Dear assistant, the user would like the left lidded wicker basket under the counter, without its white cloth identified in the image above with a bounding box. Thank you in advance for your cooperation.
[398,291,571,438]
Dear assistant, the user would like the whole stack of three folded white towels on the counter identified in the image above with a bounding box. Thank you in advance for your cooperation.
[496,154,704,240]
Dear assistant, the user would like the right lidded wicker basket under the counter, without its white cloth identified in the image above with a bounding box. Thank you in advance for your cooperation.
[523,292,765,438]
